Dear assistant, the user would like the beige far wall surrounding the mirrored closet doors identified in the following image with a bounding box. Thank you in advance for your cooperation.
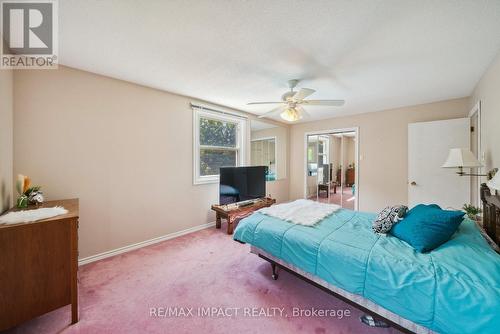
[289,98,469,211]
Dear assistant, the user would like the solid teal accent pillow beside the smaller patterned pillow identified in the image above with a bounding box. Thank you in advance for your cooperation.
[390,204,465,253]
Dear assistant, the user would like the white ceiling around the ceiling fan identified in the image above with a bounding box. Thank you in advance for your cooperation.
[59,0,500,123]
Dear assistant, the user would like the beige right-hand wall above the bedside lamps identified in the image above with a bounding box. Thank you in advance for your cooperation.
[469,54,500,171]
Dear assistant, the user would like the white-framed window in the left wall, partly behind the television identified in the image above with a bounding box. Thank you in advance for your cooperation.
[194,108,246,184]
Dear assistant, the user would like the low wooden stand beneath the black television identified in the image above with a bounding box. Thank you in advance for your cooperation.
[212,197,276,234]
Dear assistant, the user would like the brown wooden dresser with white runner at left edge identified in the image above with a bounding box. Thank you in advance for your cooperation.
[0,199,78,331]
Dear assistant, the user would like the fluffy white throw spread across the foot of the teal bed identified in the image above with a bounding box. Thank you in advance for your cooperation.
[258,199,340,226]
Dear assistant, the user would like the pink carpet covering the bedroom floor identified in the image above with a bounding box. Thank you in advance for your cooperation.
[4,225,399,334]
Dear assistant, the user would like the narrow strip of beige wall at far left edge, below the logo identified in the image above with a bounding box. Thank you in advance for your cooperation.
[0,70,13,213]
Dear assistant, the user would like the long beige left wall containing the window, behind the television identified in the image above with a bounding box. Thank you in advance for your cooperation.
[14,67,288,257]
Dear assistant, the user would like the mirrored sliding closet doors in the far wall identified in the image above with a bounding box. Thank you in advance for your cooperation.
[304,128,359,210]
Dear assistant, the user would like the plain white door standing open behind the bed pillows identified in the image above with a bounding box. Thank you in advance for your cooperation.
[408,118,470,209]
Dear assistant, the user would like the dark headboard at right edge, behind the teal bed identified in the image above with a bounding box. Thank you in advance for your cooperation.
[481,183,500,246]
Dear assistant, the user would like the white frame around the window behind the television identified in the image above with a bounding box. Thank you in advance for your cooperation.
[193,108,247,185]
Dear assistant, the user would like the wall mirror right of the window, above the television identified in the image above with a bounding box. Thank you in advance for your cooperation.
[250,120,287,181]
